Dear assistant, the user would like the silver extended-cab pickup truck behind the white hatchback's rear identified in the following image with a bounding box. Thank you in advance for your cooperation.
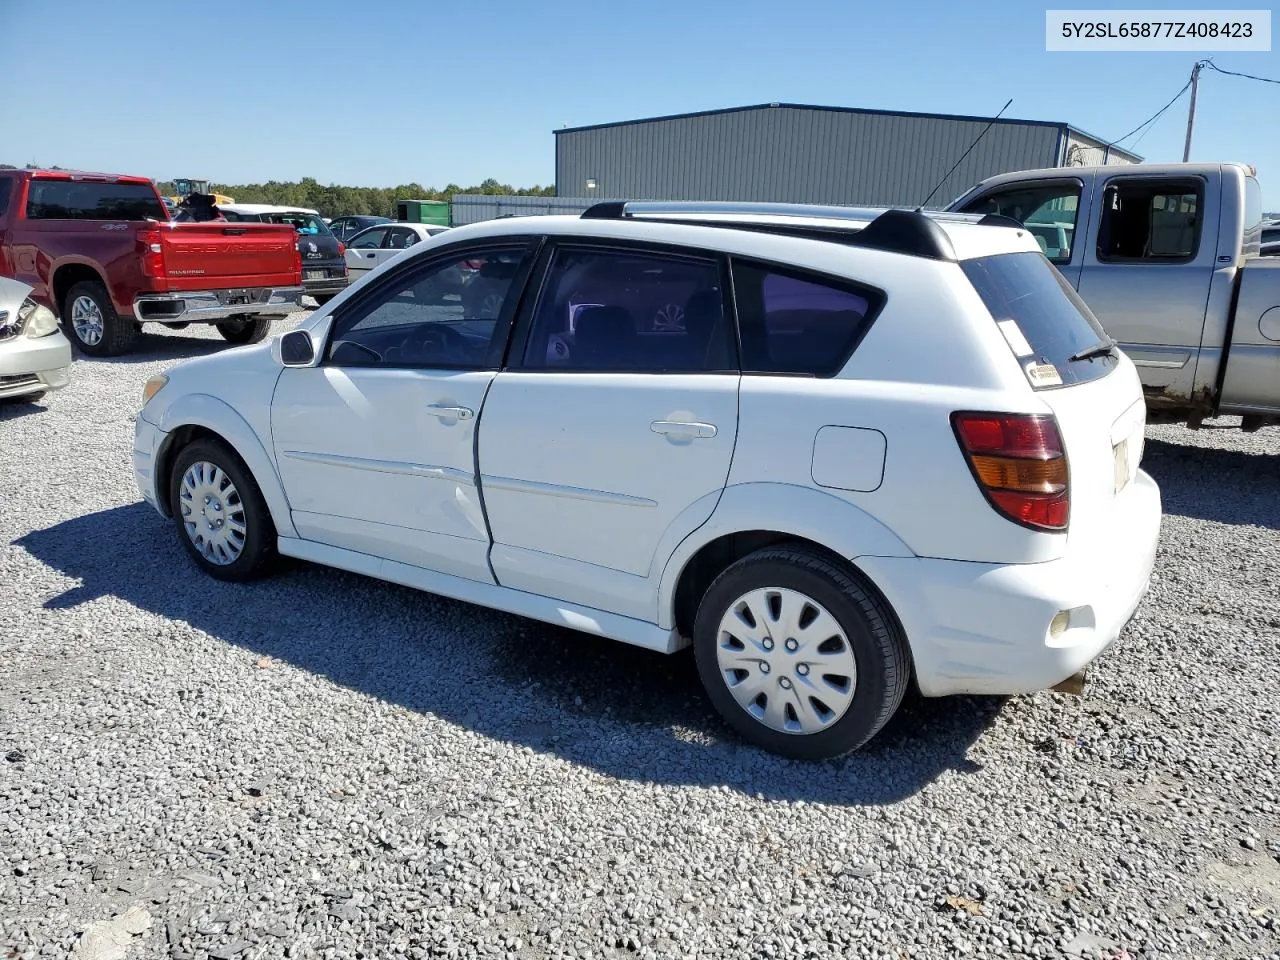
[948,163,1280,430]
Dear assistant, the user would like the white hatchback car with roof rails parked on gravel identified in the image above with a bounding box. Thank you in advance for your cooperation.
[133,204,1161,759]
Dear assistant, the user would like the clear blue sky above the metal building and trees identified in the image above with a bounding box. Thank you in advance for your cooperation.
[0,0,1280,209]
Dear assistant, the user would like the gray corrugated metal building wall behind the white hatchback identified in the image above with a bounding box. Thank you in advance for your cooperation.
[556,106,1062,206]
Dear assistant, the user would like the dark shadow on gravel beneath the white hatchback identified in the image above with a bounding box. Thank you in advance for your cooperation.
[17,503,1004,805]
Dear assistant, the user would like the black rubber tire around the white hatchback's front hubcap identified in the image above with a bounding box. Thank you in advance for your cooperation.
[169,439,276,582]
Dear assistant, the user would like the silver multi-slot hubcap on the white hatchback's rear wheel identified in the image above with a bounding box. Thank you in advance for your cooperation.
[716,586,858,735]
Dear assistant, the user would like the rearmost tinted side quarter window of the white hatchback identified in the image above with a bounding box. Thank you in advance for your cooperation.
[733,260,884,376]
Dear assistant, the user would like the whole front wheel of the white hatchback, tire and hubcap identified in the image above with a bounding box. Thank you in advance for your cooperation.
[169,440,276,581]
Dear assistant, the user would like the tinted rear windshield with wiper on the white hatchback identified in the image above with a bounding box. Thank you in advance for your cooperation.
[960,253,1119,389]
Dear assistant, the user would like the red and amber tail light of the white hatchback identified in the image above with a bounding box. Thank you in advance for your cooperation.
[951,413,1071,532]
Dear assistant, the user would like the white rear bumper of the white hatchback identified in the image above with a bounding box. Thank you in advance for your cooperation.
[858,470,1161,696]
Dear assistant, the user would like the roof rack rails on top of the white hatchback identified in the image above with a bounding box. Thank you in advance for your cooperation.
[581,200,1023,260]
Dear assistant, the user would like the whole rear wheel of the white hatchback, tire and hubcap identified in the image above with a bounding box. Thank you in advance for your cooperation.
[694,547,910,760]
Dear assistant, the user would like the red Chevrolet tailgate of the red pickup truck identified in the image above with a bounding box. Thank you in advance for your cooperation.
[161,221,302,291]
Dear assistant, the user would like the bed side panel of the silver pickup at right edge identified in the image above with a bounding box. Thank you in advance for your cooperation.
[1219,257,1280,413]
